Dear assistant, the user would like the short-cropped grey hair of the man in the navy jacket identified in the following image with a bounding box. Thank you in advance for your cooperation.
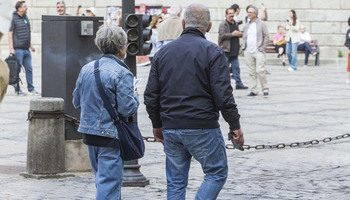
[184,3,210,33]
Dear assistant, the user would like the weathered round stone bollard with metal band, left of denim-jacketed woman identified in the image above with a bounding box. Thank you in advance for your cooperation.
[21,97,73,179]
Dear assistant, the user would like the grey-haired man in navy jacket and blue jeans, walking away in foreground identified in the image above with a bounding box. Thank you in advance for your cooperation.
[144,4,244,200]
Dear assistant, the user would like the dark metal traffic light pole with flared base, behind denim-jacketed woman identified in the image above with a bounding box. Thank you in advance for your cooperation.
[122,0,149,187]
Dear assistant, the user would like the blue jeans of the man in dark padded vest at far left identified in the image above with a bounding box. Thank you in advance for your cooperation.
[15,49,34,92]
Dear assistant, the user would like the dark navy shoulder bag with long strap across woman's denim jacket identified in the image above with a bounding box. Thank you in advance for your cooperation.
[94,60,145,161]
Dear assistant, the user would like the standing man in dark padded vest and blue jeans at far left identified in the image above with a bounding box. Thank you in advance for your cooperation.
[8,1,40,96]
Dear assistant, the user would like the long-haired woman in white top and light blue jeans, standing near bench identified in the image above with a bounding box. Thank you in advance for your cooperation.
[286,10,300,71]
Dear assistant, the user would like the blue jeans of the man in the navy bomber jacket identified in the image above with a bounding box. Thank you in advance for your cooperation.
[163,128,228,200]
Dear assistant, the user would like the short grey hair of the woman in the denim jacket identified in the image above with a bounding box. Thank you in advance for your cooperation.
[95,24,127,54]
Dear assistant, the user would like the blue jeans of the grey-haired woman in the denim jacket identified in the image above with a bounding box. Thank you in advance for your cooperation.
[88,145,124,200]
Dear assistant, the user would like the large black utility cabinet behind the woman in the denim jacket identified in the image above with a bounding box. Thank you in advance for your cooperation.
[42,15,103,140]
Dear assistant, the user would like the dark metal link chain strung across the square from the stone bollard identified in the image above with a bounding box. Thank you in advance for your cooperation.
[65,114,350,150]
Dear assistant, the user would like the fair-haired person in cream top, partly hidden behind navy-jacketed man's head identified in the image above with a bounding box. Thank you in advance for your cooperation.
[158,4,183,49]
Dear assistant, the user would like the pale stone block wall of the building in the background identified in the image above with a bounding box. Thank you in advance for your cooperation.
[0,0,350,64]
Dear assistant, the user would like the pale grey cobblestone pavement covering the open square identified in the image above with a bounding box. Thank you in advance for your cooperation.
[0,62,350,200]
